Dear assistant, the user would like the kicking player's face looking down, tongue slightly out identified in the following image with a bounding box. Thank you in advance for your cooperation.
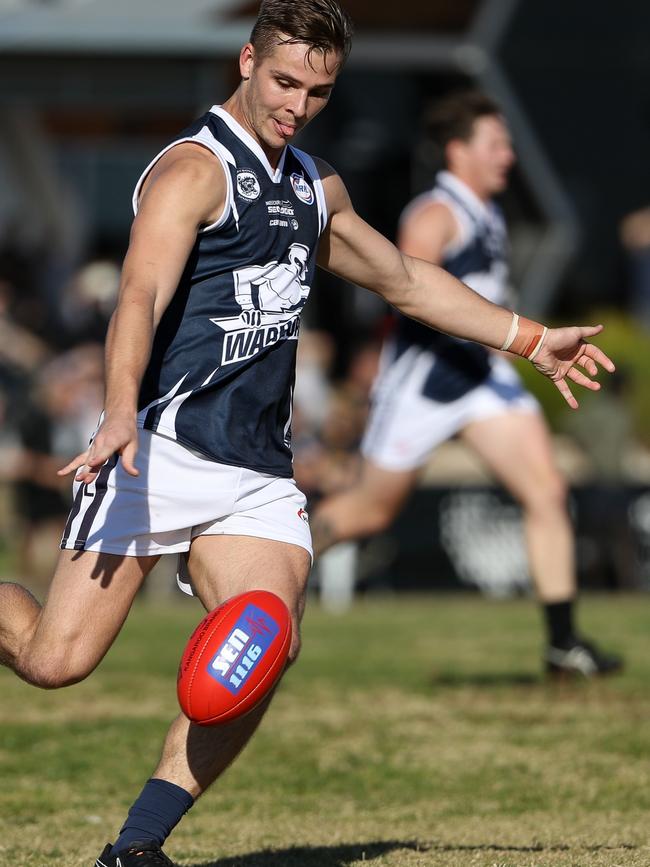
[240,42,340,158]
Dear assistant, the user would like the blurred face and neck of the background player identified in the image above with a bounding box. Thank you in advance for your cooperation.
[458,115,515,199]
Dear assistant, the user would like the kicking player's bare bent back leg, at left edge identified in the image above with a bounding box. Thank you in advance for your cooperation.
[0,551,158,689]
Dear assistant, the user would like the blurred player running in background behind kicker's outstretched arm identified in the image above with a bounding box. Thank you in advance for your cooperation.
[312,90,622,676]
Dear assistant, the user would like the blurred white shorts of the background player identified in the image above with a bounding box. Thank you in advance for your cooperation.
[361,347,539,472]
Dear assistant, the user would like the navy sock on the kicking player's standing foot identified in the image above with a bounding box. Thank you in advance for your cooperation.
[111,779,194,855]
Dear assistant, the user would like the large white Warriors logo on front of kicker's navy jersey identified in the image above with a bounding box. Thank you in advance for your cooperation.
[211,244,310,366]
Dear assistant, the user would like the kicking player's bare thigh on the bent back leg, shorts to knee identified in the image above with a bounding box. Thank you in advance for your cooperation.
[31,550,158,674]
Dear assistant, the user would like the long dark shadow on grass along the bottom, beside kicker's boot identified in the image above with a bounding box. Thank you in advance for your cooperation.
[185,840,638,867]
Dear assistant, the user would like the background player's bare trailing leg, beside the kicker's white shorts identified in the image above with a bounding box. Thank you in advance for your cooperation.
[310,459,419,557]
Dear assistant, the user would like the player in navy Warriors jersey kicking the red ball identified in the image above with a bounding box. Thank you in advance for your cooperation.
[0,6,613,867]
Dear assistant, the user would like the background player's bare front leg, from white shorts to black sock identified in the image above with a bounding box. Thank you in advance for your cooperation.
[461,413,576,602]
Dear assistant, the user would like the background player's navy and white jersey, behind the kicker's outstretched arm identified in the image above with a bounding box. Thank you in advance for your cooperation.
[387,172,508,401]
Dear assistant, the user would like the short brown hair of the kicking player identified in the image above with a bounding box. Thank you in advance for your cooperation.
[250,0,353,66]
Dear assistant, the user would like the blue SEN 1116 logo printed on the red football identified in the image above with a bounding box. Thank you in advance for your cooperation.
[208,605,280,695]
